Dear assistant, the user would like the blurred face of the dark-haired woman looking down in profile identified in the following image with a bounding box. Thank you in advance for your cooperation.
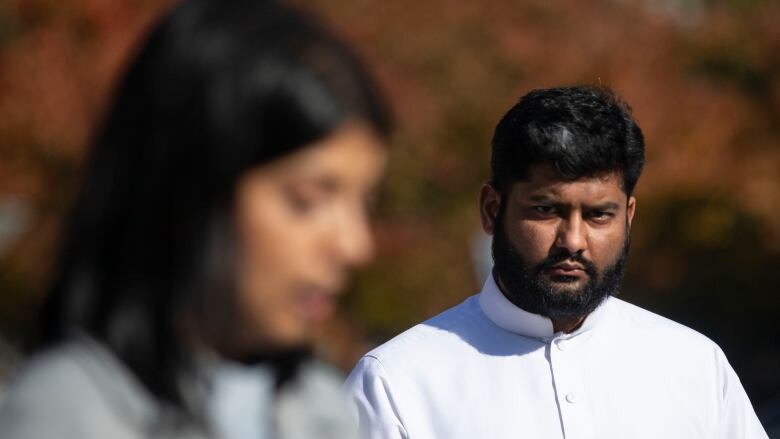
[231,124,386,349]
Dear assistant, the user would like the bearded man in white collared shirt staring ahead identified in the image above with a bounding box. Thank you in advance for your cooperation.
[345,87,767,439]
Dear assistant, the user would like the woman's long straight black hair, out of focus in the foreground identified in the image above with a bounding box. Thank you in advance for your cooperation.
[41,0,389,412]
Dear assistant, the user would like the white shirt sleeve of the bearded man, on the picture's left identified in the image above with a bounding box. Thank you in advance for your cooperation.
[344,356,409,439]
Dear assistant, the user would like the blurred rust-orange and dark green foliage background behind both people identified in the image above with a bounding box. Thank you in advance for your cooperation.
[0,0,780,430]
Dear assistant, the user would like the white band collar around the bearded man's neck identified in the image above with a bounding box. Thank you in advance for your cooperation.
[479,273,610,341]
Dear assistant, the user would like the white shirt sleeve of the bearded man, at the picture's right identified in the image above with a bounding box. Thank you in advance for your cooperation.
[716,348,769,439]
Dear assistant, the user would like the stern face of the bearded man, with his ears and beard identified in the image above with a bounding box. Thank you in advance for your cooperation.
[481,165,636,320]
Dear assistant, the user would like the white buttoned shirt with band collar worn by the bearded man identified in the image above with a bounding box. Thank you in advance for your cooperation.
[345,276,767,439]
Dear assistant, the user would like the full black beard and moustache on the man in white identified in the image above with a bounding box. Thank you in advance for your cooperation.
[492,208,629,321]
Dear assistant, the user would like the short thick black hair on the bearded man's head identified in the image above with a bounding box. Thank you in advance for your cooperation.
[490,86,645,197]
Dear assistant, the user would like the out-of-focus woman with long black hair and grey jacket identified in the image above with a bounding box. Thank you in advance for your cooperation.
[0,0,389,439]
